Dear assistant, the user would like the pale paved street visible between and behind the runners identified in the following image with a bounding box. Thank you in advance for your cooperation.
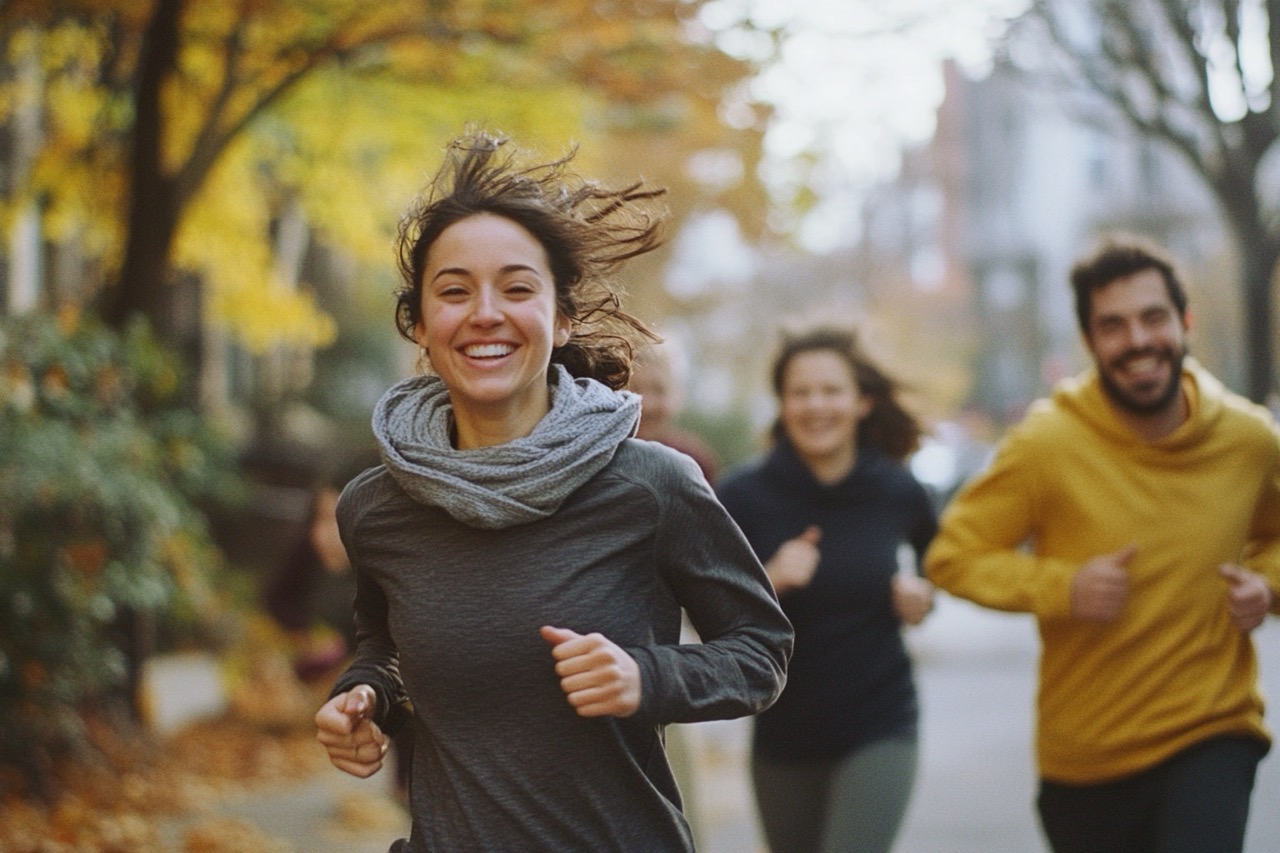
[698,597,1280,853]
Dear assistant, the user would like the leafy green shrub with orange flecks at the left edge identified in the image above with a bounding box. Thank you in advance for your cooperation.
[0,311,237,775]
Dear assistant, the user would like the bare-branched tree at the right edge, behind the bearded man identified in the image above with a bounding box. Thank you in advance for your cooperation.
[1004,0,1280,402]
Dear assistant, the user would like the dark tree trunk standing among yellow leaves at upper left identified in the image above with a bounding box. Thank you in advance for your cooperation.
[102,0,183,337]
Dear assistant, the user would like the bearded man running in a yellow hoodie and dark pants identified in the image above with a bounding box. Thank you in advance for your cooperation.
[925,237,1280,853]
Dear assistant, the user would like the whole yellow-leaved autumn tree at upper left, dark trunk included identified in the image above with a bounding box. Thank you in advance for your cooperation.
[0,0,763,425]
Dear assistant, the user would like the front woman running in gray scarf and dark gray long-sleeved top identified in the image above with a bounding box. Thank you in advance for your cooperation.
[316,133,792,853]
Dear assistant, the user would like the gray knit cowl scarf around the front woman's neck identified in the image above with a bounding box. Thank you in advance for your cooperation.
[374,364,640,530]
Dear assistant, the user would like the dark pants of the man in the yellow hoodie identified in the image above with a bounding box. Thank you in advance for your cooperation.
[1038,736,1267,853]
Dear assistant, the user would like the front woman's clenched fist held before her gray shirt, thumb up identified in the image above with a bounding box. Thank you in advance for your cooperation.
[540,625,640,717]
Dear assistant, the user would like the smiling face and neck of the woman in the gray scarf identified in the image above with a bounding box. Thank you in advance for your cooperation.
[416,214,570,447]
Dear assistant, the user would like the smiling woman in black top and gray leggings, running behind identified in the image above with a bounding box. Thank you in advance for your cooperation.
[719,327,937,853]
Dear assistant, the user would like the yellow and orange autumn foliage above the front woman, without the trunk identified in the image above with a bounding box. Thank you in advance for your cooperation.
[0,0,762,352]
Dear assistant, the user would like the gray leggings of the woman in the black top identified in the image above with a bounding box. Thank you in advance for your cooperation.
[751,738,919,853]
